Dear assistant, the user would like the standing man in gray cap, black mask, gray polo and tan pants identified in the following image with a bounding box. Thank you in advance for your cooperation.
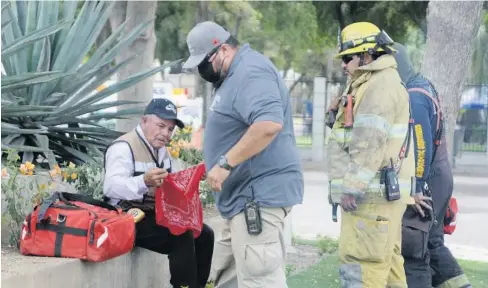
[183,22,303,288]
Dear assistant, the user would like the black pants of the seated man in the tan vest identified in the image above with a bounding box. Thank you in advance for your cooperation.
[135,211,214,288]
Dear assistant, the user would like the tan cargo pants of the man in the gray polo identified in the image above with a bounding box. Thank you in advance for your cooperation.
[212,207,291,288]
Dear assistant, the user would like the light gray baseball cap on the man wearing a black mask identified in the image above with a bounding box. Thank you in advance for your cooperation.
[182,21,230,69]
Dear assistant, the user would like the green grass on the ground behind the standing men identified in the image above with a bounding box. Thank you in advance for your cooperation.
[288,237,488,288]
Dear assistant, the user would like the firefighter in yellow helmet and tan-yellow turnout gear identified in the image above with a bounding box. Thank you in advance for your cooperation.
[328,22,415,287]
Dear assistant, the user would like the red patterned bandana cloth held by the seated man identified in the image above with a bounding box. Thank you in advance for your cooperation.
[155,163,205,238]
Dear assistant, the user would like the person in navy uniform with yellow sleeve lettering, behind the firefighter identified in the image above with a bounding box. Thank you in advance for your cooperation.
[393,43,471,288]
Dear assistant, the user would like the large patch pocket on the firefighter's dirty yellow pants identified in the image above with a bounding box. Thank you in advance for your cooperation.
[339,213,389,262]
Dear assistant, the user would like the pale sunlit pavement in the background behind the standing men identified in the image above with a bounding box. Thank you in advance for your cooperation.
[292,171,488,261]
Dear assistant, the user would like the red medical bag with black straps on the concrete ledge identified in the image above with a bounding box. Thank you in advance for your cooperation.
[20,192,135,262]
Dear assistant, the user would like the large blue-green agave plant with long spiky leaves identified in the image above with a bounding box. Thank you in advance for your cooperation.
[1,1,176,166]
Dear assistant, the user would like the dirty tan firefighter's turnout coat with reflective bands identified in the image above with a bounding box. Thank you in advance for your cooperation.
[327,55,415,204]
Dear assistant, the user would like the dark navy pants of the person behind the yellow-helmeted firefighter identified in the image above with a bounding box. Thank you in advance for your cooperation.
[403,162,471,288]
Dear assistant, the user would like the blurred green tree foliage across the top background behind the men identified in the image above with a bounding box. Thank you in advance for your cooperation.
[156,1,488,90]
